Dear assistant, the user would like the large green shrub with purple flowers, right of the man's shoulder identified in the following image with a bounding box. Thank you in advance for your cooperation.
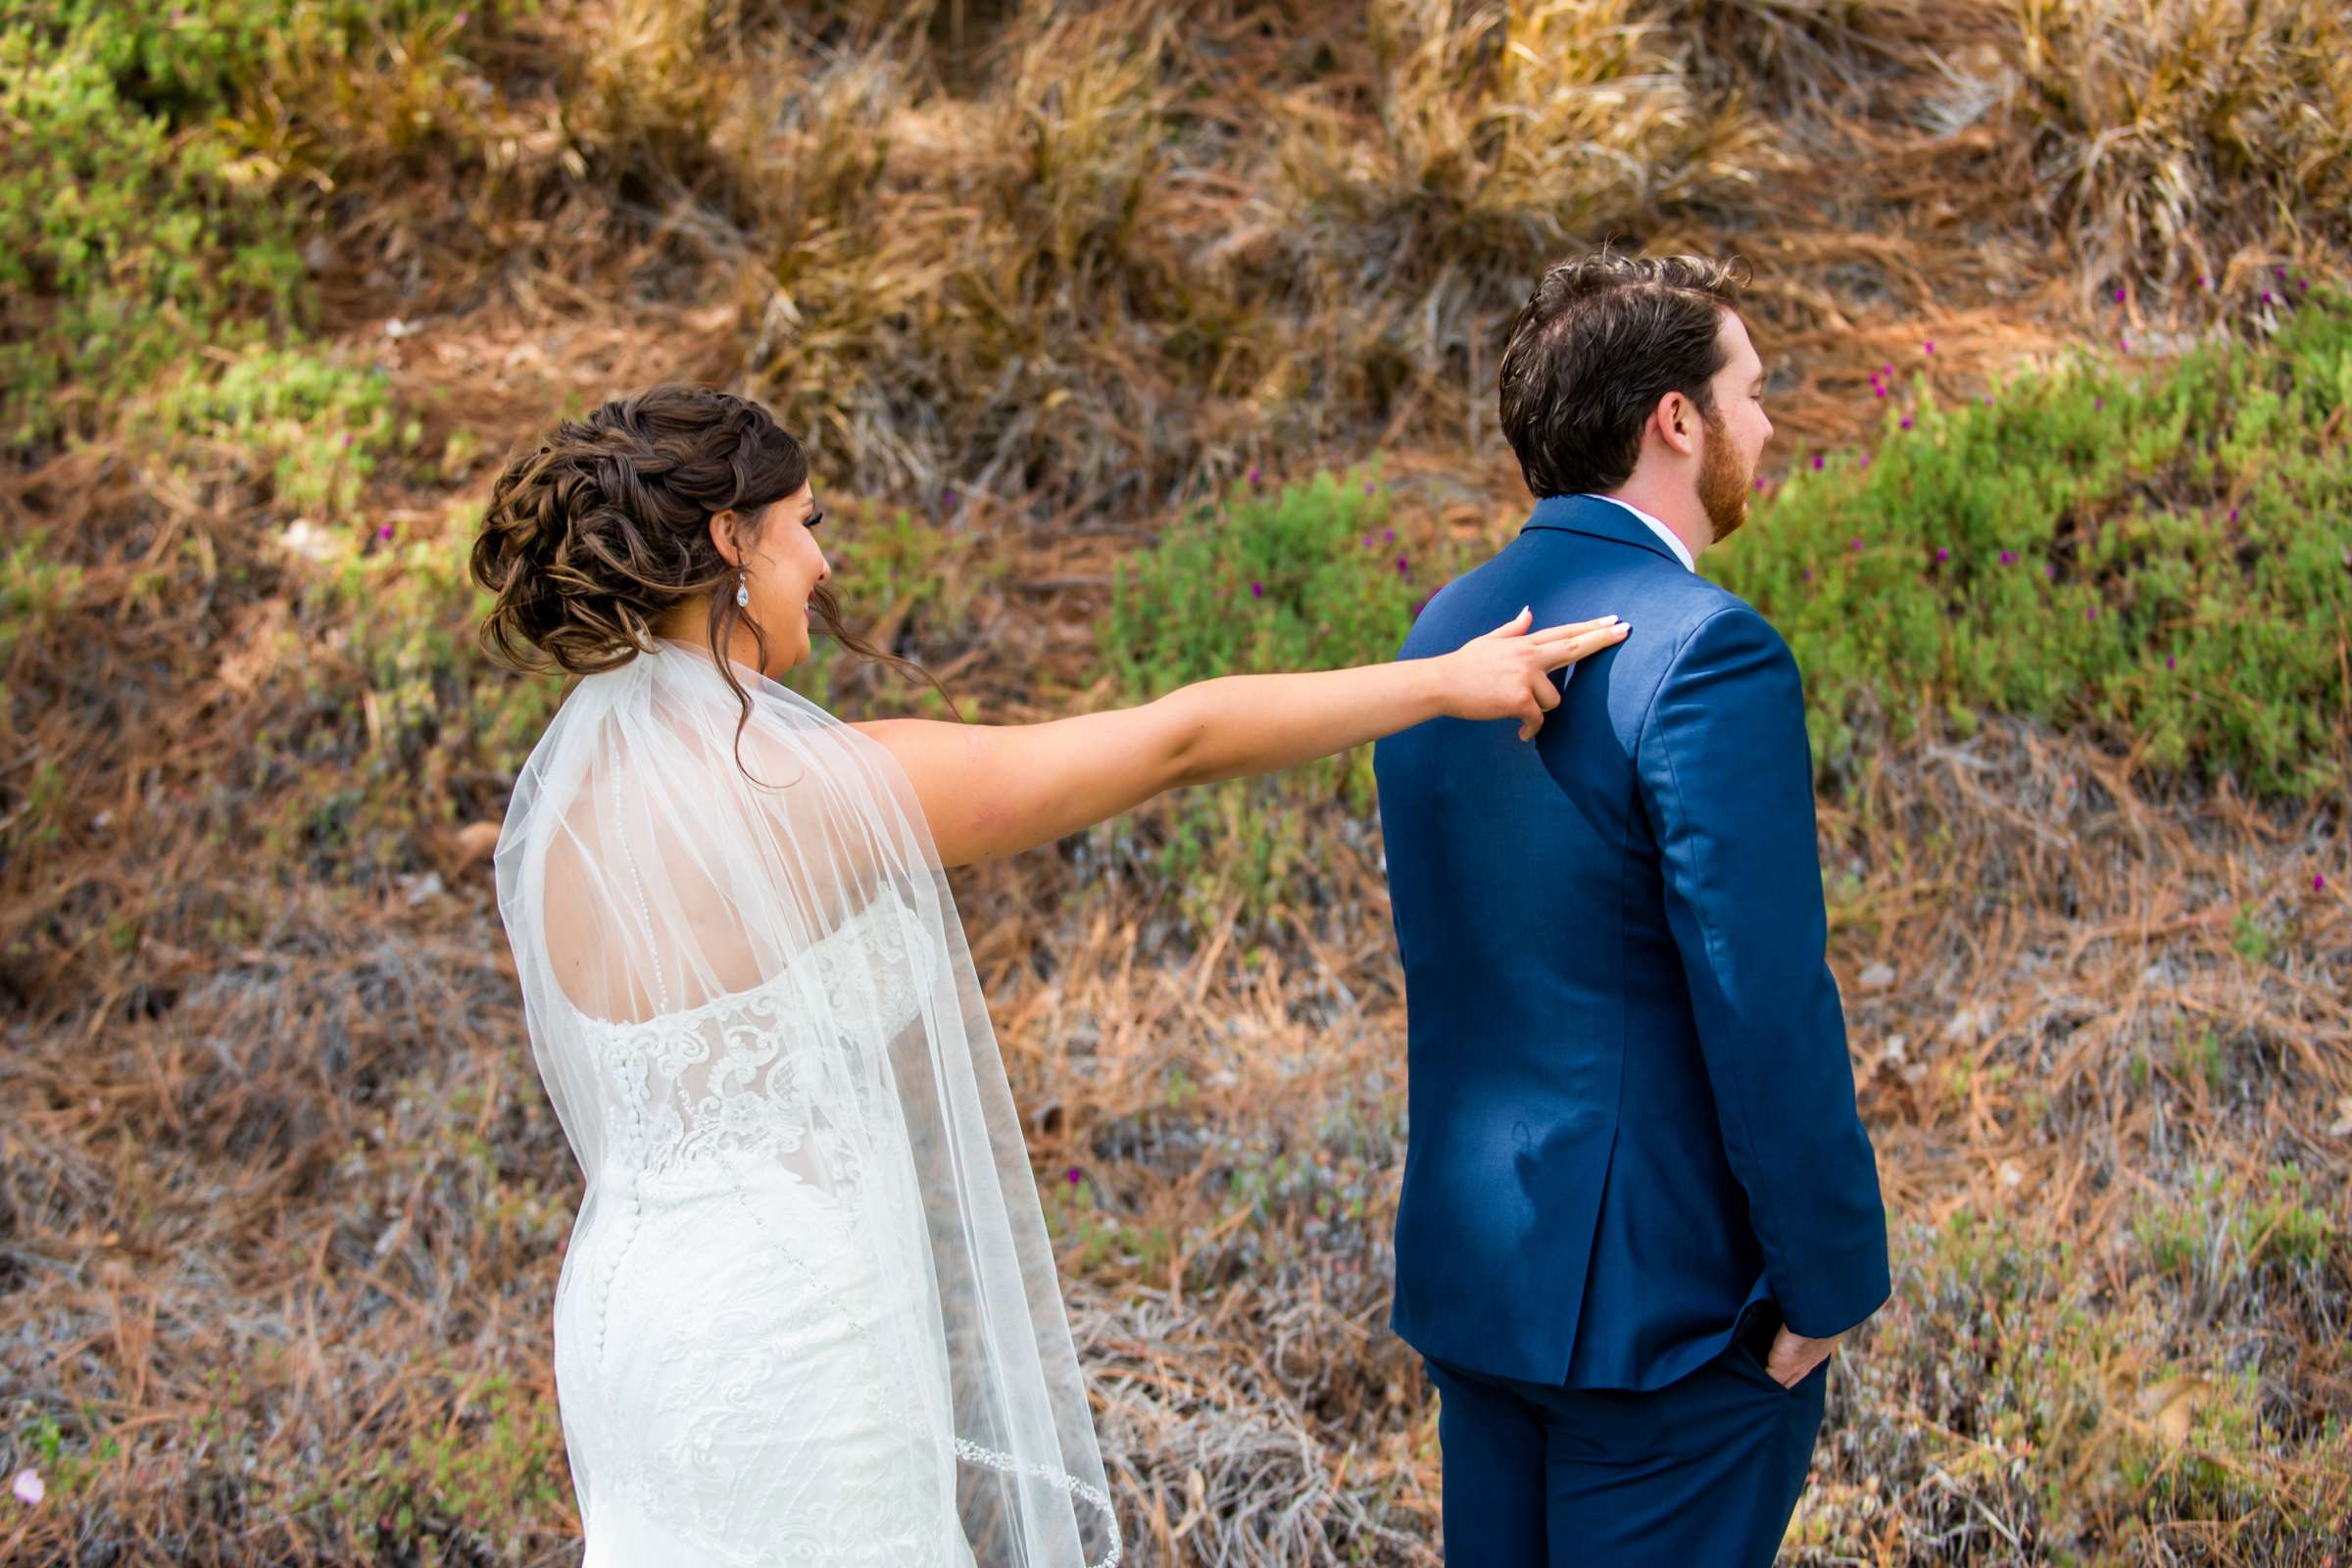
[1707,291,2352,797]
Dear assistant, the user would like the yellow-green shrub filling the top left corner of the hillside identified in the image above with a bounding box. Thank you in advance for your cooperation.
[0,0,486,447]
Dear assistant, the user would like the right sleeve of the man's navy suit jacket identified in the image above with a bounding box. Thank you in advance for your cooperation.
[1637,604,1888,1338]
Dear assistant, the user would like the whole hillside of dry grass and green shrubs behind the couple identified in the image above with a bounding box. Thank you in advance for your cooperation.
[0,0,2352,1568]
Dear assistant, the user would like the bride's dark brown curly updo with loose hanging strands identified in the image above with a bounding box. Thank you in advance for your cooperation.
[468,383,955,757]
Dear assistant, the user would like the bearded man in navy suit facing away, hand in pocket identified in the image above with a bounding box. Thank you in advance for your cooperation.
[1374,254,1888,1568]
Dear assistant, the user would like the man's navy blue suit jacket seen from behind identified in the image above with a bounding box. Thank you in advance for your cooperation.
[1374,496,1888,1390]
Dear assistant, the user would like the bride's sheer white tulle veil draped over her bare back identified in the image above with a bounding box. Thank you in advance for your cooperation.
[494,639,1119,1568]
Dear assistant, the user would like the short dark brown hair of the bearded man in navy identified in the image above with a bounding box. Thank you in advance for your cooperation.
[1498,247,1747,499]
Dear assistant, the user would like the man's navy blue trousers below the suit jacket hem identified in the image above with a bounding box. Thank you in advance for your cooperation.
[1423,1314,1830,1568]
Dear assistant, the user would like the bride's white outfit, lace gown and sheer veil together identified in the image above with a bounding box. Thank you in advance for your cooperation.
[496,639,1119,1568]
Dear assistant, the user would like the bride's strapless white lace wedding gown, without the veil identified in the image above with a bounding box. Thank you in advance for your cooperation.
[555,888,971,1568]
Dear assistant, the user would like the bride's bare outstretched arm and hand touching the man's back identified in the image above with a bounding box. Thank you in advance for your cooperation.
[857,612,1628,865]
